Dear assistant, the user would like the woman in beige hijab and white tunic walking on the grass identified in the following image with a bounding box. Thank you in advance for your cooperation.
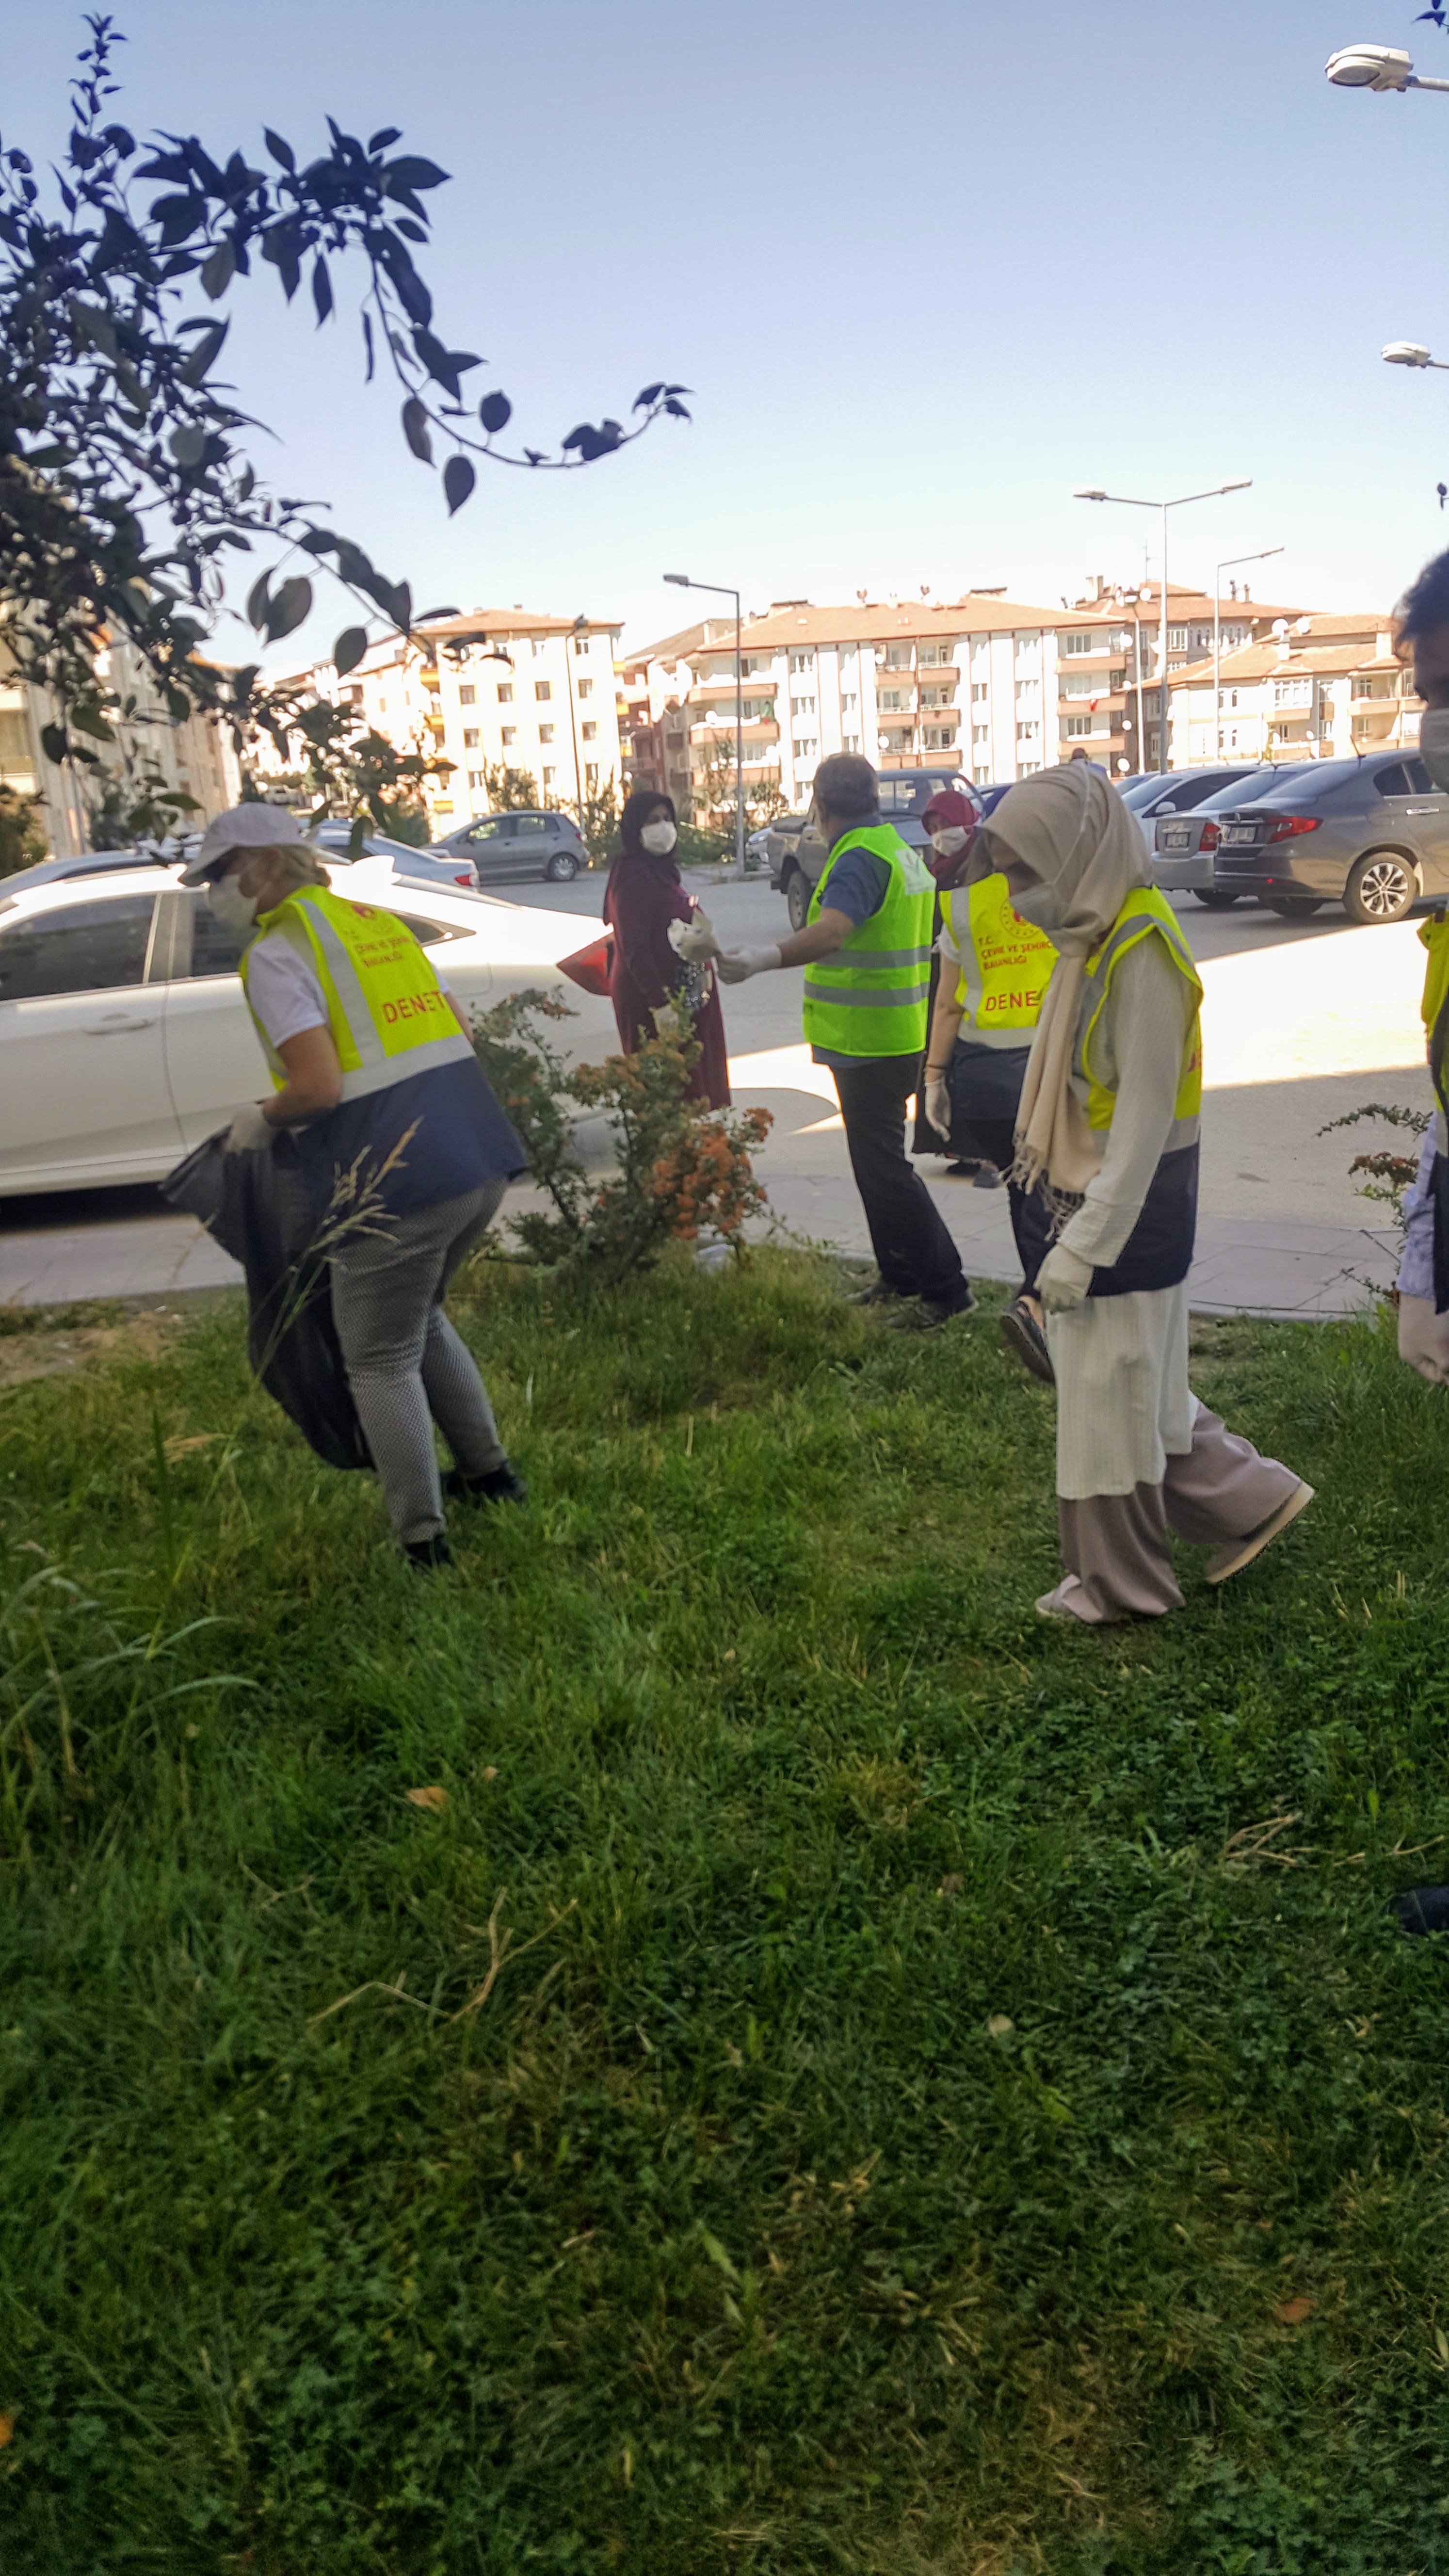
[972,762,1312,1626]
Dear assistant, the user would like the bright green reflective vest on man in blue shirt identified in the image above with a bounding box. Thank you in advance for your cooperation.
[805,822,936,1056]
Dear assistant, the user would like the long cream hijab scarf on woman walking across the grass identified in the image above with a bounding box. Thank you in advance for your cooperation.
[972,760,1153,1216]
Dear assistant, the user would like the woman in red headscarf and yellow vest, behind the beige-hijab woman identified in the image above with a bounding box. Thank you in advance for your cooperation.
[918,788,1057,1384]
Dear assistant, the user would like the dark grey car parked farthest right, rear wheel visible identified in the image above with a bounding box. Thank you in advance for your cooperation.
[1186,752,1449,925]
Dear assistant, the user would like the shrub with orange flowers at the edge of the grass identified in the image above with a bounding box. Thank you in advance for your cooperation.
[474,992,771,1280]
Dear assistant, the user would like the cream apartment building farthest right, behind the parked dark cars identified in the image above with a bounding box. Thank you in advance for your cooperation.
[1168,611,1423,768]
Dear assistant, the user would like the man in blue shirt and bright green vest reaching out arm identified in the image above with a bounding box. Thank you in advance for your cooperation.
[719,752,975,1329]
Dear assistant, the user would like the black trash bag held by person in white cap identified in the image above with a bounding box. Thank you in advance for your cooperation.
[160,1128,371,1468]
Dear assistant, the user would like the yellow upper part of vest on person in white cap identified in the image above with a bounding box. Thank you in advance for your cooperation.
[240,886,472,1100]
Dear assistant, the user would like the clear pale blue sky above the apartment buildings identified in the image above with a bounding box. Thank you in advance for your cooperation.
[11,0,1449,657]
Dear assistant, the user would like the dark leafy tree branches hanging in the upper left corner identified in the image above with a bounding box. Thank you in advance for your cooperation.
[0,16,689,829]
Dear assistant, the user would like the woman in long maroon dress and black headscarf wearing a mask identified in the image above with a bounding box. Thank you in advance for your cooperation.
[603,788,730,1110]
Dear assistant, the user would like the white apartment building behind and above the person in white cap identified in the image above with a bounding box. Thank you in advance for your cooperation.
[255,608,621,837]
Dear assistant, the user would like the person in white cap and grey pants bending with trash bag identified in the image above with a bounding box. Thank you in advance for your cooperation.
[180,804,526,1566]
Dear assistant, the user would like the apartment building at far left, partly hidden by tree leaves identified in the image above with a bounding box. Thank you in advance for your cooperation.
[0,639,242,858]
